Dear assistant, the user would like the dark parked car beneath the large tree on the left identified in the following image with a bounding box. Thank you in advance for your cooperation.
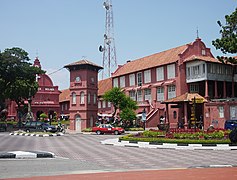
[24,121,57,133]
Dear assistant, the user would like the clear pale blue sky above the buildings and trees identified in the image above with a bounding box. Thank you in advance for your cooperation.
[0,0,237,90]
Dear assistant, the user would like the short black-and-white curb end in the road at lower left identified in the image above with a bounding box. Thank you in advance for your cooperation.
[0,151,55,159]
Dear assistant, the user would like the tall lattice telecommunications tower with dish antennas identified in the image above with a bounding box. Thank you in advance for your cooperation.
[99,0,117,79]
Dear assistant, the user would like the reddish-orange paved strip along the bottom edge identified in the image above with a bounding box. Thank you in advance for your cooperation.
[5,167,237,180]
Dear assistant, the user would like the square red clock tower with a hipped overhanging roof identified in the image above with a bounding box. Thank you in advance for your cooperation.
[64,60,103,132]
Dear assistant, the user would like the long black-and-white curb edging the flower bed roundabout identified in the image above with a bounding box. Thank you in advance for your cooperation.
[101,138,237,150]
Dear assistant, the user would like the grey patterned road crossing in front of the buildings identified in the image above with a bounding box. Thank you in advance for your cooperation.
[0,133,237,178]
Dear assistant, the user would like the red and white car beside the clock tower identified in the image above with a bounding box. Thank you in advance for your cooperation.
[92,124,124,135]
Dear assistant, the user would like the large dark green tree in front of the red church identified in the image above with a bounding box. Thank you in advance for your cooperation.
[0,47,44,124]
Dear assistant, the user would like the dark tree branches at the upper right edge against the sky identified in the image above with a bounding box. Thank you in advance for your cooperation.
[212,8,237,64]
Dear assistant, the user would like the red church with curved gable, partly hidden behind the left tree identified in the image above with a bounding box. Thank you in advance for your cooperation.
[8,58,60,119]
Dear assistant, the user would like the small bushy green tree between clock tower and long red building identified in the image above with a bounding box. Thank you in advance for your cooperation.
[103,87,138,126]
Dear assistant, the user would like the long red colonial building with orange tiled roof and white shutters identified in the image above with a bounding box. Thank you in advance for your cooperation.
[98,38,237,129]
